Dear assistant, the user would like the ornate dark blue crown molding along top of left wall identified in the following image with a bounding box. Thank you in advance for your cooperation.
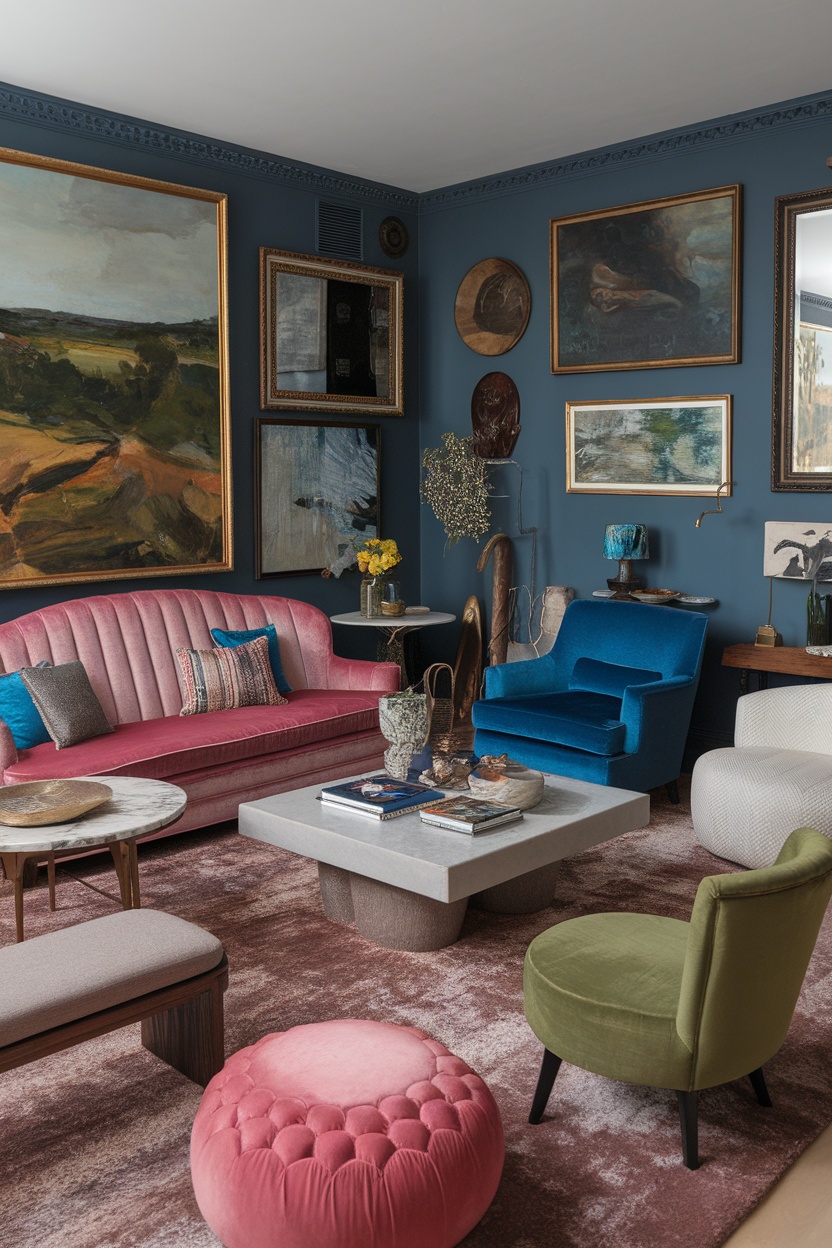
[0,84,419,212]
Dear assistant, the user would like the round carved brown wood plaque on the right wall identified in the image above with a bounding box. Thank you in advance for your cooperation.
[454,256,531,356]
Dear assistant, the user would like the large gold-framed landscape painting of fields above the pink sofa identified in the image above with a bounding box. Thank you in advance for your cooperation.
[0,150,231,588]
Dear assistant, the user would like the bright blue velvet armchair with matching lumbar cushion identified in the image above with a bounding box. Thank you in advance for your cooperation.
[472,599,707,796]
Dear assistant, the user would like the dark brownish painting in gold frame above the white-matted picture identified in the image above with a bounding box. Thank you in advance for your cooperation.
[550,186,741,373]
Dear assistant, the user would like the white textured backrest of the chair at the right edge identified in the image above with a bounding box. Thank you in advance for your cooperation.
[733,684,832,754]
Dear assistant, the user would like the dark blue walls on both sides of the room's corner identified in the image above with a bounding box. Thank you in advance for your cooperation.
[0,86,832,741]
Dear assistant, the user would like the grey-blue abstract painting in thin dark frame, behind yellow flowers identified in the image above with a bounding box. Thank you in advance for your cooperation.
[254,417,379,580]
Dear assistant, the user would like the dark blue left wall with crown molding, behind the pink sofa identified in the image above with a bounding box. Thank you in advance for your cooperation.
[0,85,419,656]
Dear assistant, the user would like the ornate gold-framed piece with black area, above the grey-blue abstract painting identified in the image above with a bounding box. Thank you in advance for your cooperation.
[259,247,404,416]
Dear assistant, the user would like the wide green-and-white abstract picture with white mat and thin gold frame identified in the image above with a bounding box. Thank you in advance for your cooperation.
[566,394,731,498]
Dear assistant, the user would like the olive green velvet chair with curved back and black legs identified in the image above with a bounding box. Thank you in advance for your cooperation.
[524,827,832,1169]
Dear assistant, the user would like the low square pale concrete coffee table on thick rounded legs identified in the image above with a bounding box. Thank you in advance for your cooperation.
[239,776,650,952]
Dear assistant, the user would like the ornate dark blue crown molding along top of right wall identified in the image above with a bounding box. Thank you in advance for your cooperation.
[419,92,832,212]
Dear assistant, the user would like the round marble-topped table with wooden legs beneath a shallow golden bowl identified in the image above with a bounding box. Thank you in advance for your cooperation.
[0,776,187,941]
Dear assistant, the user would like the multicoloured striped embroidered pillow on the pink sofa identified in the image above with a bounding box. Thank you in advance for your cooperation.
[176,636,287,715]
